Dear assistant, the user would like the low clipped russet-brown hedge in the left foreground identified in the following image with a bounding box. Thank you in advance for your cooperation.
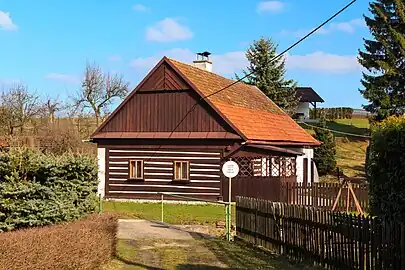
[0,215,117,270]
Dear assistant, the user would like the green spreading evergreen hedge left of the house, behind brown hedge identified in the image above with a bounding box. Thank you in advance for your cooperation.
[0,149,97,231]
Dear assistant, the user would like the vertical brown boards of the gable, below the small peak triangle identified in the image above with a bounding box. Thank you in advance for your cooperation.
[101,90,233,132]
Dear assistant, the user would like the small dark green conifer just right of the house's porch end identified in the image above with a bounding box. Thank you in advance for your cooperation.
[314,120,336,175]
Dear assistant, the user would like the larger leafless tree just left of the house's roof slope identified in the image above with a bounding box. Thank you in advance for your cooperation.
[74,64,129,126]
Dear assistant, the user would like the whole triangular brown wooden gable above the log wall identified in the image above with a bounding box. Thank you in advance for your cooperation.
[91,59,239,138]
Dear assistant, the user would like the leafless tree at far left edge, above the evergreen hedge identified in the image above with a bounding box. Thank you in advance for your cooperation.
[0,84,43,135]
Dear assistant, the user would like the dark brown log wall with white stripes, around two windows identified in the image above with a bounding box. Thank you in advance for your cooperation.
[106,148,221,200]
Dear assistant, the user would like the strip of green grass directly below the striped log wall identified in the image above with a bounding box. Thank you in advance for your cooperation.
[103,201,235,225]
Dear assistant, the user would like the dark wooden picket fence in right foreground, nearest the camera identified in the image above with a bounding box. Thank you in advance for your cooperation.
[236,197,405,270]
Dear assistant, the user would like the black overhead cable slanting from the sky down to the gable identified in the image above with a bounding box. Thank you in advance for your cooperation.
[147,0,357,159]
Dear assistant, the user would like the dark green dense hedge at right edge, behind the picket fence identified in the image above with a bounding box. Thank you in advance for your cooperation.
[366,117,405,221]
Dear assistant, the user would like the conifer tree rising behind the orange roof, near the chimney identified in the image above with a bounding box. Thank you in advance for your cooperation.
[238,38,299,115]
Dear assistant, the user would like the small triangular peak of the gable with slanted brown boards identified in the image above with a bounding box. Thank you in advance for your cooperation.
[139,62,190,92]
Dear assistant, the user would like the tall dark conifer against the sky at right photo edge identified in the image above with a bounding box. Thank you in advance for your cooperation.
[359,0,405,120]
